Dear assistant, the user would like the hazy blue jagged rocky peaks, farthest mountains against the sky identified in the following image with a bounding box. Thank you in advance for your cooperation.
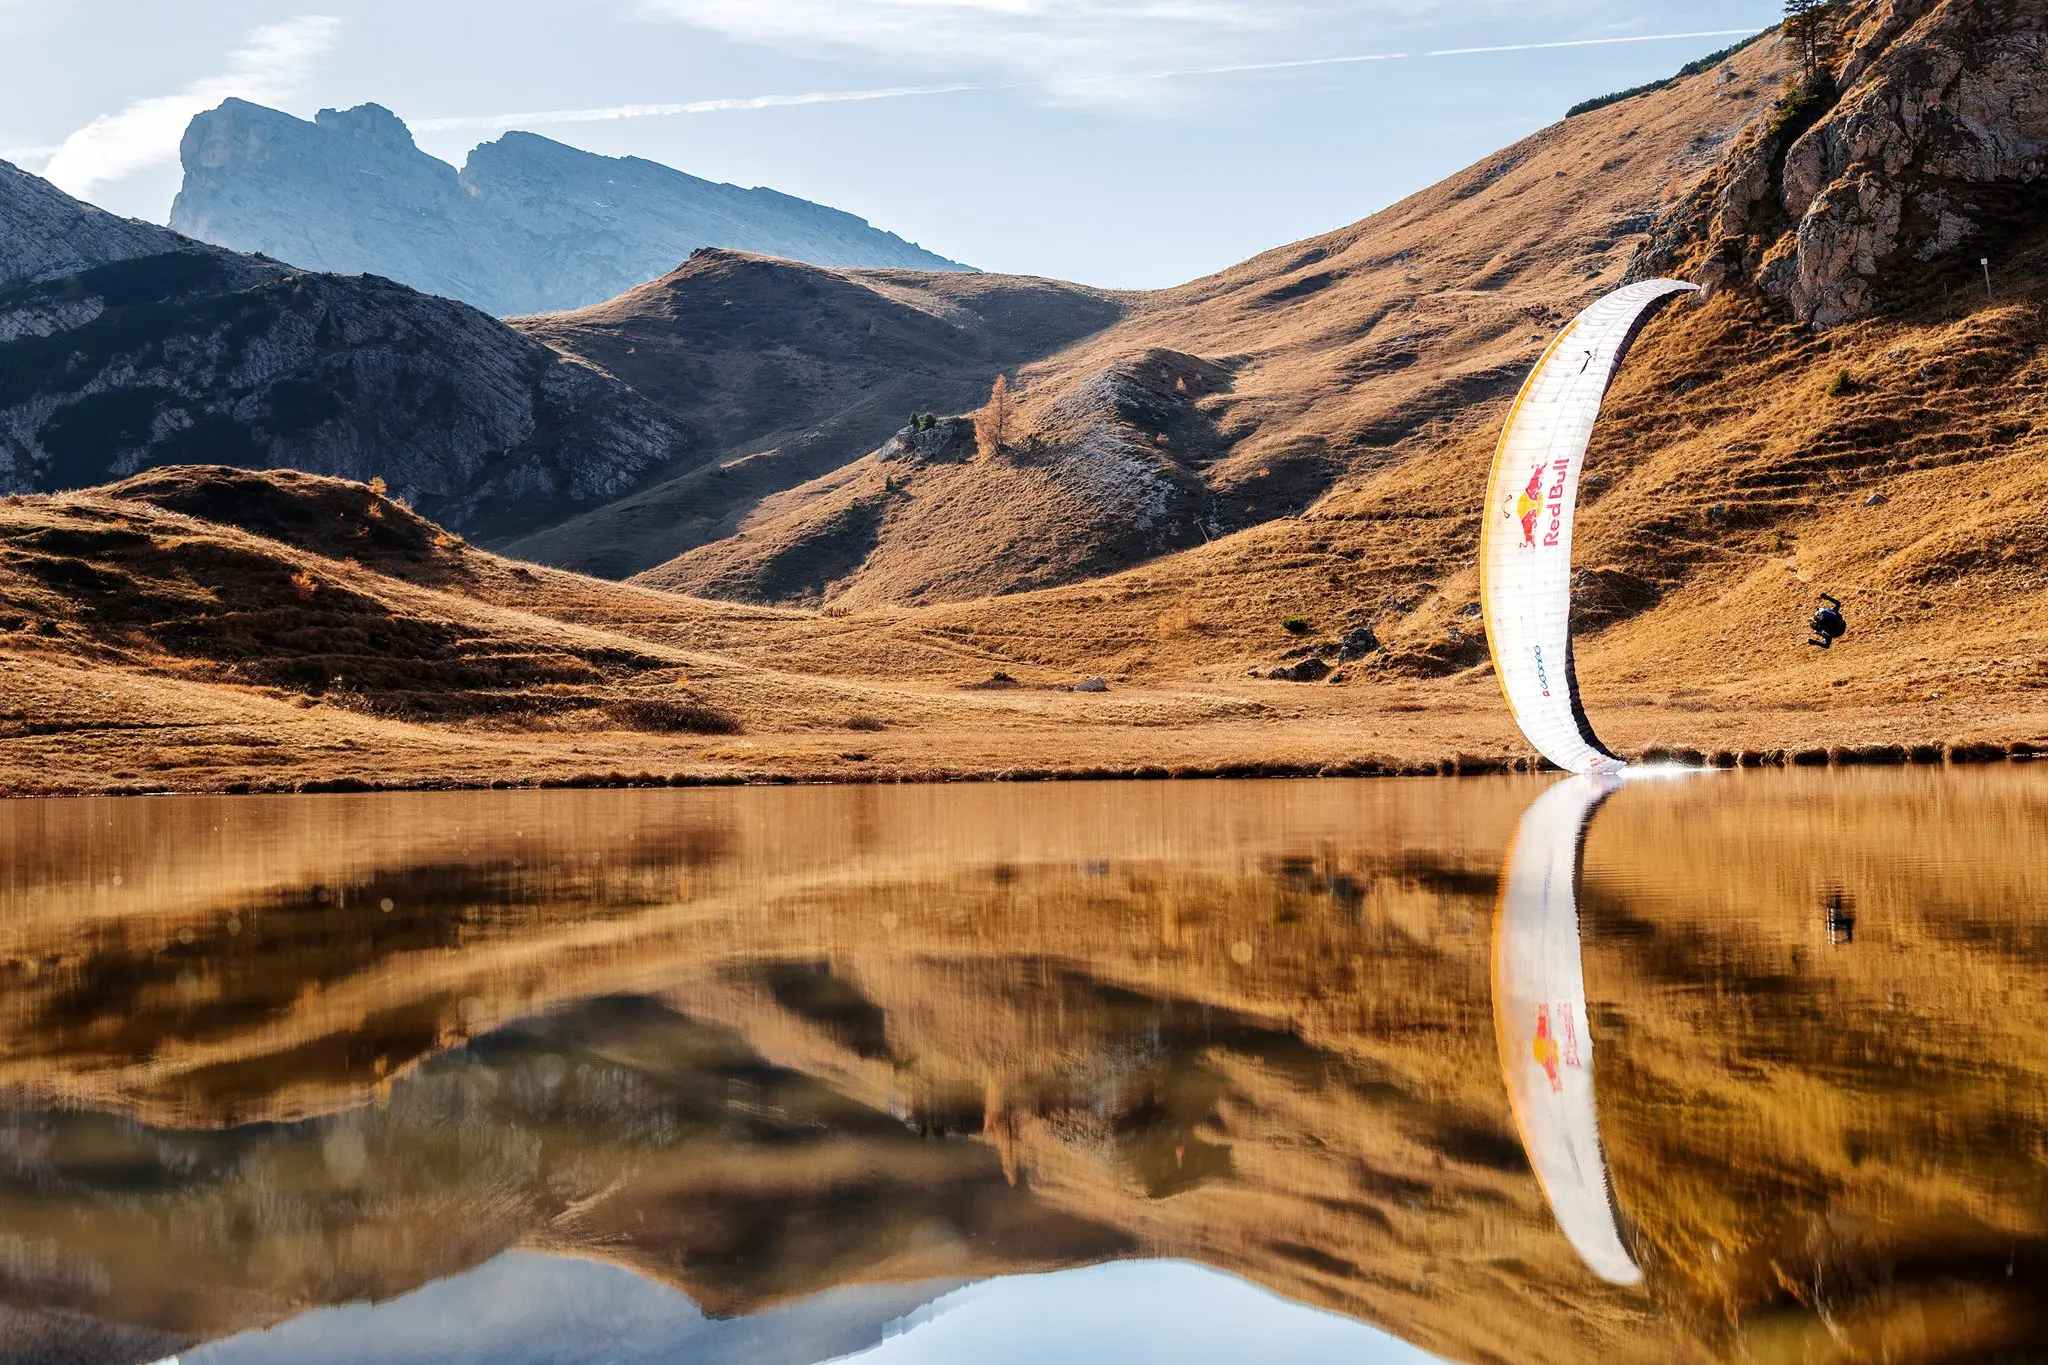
[170,100,967,317]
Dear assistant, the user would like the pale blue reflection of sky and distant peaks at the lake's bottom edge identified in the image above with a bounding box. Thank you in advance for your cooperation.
[166,1252,1436,1365]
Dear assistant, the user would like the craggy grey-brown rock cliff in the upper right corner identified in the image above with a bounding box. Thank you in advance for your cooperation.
[1638,0,2048,327]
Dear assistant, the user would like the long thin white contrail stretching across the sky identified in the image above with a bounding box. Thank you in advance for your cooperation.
[412,29,1755,133]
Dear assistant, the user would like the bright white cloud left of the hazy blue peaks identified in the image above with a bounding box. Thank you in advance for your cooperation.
[43,14,340,194]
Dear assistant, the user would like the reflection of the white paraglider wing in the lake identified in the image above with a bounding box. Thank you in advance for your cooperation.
[1493,776,1642,1285]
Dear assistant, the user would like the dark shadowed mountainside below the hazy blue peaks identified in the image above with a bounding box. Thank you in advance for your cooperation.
[0,152,1124,548]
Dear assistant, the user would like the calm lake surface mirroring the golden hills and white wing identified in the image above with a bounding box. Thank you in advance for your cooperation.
[0,767,2048,1365]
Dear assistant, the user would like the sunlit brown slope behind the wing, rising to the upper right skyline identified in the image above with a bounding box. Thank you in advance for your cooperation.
[645,30,1786,606]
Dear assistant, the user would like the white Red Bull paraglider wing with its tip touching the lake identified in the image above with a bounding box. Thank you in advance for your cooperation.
[1479,280,1698,774]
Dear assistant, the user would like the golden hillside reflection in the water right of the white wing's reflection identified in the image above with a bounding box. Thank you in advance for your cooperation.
[1581,778,2048,1363]
